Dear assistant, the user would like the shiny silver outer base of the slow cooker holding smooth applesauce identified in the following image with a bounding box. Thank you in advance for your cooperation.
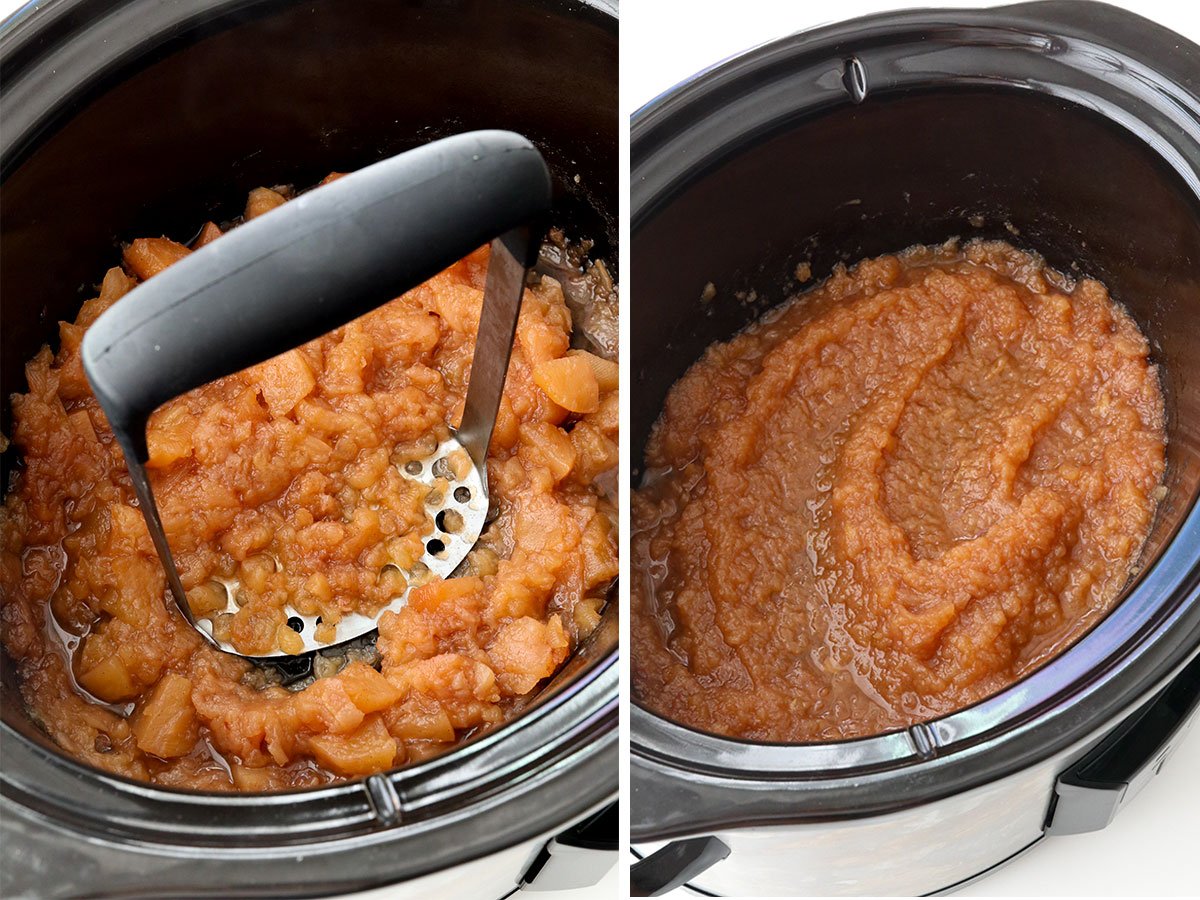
[632,659,1200,896]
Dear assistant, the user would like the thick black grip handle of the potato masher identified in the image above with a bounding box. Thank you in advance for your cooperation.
[83,131,551,462]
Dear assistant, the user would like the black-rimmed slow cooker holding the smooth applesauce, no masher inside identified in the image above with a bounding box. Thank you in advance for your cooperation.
[629,2,1200,896]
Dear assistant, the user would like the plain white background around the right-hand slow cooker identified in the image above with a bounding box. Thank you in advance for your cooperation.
[620,0,1200,896]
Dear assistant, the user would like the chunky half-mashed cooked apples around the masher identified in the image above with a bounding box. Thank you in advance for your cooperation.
[0,181,618,791]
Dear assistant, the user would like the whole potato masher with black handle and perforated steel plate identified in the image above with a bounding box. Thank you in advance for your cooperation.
[82,131,551,661]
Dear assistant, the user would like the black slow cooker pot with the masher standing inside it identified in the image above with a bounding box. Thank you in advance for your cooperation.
[0,0,618,898]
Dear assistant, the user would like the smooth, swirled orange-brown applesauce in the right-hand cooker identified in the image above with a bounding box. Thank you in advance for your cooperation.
[631,242,1165,743]
